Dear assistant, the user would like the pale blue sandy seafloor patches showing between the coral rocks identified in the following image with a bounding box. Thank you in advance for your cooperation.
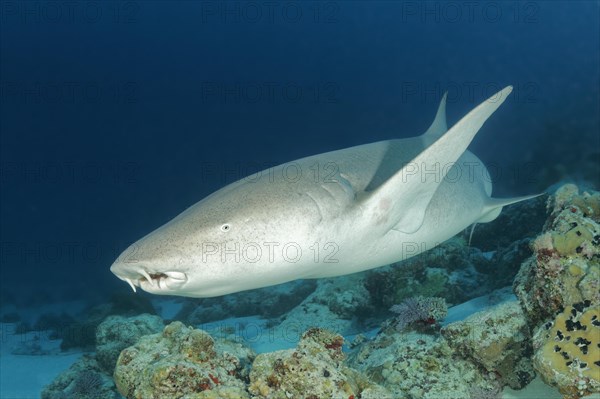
[0,294,600,399]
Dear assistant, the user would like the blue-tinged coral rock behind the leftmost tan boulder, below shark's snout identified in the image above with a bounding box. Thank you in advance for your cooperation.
[96,314,164,375]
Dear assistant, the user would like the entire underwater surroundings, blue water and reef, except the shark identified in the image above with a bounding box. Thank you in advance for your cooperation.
[0,0,600,399]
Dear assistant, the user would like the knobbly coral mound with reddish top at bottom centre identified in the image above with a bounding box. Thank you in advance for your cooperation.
[249,328,391,399]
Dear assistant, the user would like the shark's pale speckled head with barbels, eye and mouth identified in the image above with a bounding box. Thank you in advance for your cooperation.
[110,177,319,297]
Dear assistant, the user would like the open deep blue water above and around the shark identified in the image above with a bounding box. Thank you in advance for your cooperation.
[0,1,600,303]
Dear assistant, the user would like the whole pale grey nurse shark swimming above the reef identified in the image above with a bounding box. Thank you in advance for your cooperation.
[111,86,533,297]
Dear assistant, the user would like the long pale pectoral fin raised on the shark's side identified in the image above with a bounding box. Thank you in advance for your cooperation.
[361,86,512,234]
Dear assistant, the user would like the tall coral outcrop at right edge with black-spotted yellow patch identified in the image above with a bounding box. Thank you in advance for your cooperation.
[513,184,600,398]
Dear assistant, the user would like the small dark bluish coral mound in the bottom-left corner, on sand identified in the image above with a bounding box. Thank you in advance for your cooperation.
[41,355,118,399]
